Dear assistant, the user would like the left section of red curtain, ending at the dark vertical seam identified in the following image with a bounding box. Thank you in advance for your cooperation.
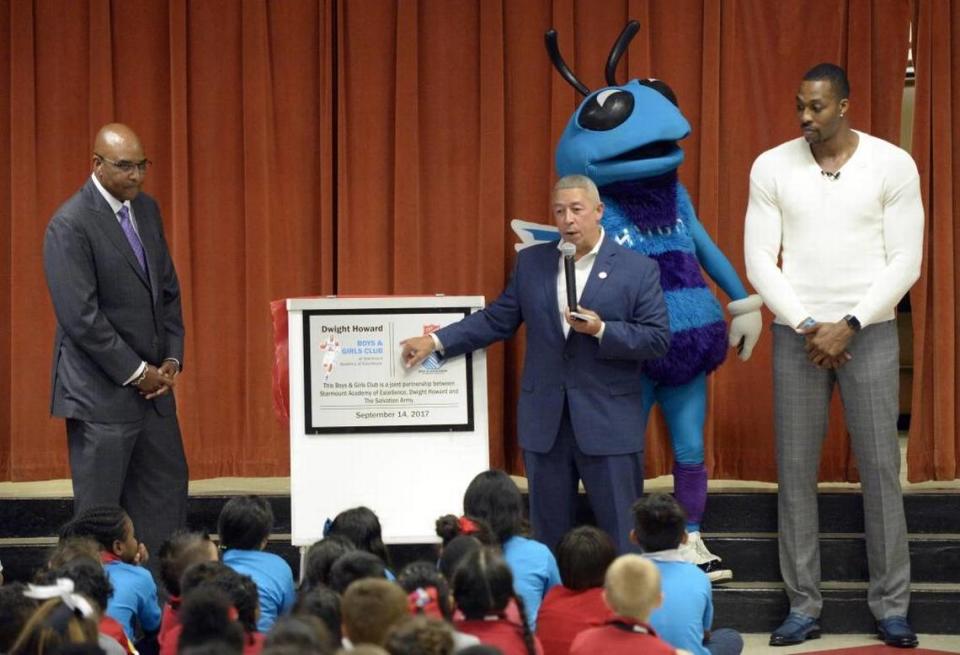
[0,0,335,480]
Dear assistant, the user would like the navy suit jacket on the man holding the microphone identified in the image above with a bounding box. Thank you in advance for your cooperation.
[437,235,670,455]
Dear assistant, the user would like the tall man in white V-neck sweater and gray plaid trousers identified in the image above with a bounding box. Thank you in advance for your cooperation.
[744,64,923,647]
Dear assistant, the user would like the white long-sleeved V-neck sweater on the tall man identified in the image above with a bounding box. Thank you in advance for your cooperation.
[743,132,923,326]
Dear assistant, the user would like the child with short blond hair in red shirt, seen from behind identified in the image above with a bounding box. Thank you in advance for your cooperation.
[570,554,685,655]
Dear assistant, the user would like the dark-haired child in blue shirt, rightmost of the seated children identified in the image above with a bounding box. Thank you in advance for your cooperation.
[630,494,743,655]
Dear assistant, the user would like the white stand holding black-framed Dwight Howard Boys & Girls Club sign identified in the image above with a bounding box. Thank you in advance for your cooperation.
[287,296,490,546]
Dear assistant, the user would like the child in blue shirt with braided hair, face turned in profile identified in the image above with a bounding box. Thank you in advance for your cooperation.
[60,505,160,642]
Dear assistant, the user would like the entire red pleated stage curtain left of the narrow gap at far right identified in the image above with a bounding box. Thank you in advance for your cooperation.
[0,0,936,480]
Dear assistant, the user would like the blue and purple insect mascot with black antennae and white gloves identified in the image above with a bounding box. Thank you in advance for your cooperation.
[546,21,762,581]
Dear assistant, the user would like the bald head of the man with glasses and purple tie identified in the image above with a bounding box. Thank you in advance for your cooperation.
[93,123,148,202]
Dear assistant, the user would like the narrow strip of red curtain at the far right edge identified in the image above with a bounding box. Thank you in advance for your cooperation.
[907,0,960,481]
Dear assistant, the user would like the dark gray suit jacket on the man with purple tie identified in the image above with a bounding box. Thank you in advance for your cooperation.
[43,180,183,423]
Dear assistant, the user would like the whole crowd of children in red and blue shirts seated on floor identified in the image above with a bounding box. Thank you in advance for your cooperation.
[0,471,756,655]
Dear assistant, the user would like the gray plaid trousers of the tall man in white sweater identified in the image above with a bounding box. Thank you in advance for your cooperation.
[773,321,910,619]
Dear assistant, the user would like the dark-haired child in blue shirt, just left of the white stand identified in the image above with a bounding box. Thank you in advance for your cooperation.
[217,496,297,633]
